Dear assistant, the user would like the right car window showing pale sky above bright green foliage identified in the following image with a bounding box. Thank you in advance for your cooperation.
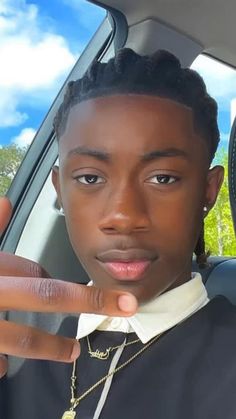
[192,55,236,256]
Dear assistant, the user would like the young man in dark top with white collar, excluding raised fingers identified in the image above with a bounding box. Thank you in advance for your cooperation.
[3,49,236,419]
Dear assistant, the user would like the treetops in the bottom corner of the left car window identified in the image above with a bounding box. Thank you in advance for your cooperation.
[0,144,26,196]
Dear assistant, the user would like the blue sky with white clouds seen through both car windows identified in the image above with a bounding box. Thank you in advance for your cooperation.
[0,0,236,151]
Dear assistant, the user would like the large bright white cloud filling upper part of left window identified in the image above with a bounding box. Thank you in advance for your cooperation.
[0,0,75,127]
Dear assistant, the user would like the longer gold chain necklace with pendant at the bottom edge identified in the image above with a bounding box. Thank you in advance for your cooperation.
[62,333,162,419]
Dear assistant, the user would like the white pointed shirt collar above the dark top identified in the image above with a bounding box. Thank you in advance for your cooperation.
[77,273,209,343]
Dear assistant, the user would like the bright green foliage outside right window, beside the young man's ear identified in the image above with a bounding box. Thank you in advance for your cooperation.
[205,150,236,256]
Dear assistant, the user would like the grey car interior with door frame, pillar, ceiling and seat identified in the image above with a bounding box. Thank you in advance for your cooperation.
[0,0,236,304]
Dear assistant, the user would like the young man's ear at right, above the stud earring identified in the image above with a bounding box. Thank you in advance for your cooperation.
[205,166,224,210]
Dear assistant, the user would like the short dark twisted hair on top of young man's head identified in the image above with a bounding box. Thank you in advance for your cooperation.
[54,48,220,161]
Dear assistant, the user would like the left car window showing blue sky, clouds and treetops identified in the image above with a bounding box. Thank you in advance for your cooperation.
[0,0,105,196]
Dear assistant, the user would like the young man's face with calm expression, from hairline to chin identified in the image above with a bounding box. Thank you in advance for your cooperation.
[53,95,222,302]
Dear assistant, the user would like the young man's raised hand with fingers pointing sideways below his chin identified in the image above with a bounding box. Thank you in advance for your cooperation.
[0,198,137,377]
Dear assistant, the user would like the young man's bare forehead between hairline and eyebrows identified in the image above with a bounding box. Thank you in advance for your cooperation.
[59,94,207,163]
